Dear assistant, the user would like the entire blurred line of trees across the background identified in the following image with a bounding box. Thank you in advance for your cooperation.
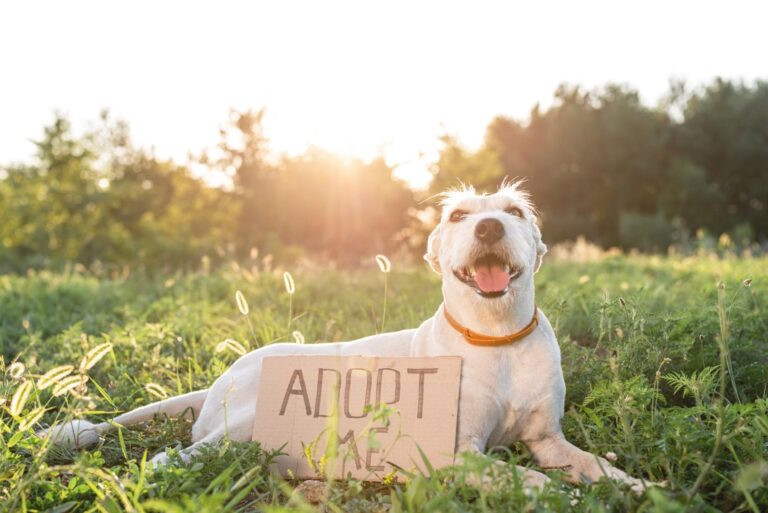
[0,79,768,271]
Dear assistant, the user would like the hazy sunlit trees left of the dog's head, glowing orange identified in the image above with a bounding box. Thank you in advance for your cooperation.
[0,112,414,271]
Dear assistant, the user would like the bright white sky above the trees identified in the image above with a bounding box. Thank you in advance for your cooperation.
[0,0,768,186]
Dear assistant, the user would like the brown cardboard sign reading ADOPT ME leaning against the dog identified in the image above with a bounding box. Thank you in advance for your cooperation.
[253,356,461,481]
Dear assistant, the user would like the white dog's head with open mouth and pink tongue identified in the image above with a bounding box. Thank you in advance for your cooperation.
[424,183,547,300]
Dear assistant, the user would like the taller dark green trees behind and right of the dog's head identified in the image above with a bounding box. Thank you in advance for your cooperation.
[433,79,768,251]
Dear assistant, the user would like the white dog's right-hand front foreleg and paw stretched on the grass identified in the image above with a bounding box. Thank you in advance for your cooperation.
[525,433,646,493]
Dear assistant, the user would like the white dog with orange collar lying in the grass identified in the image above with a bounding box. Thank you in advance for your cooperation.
[45,184,643,491]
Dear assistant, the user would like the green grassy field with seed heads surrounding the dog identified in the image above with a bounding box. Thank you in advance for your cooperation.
[0,255,768,513]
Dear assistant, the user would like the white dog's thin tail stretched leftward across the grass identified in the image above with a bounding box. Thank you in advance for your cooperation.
[37,390,208,449]
